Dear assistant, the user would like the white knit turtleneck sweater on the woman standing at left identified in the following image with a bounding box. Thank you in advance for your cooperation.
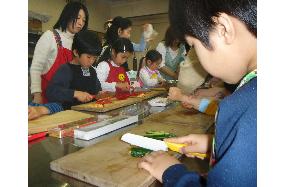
[30,29,74,93]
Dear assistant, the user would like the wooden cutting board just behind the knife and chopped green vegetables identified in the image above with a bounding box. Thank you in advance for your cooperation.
[144,105,215,130]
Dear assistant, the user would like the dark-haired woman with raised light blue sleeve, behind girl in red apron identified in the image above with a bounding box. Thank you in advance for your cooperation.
[97,16,146,71]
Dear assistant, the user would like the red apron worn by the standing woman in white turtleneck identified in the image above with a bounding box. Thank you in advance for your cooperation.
[41,30,73,103]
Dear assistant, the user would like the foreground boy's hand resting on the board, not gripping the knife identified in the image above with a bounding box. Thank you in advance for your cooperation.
[138,151,180,182]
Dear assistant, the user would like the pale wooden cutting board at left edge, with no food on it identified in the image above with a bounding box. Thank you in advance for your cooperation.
[29,110,93,134]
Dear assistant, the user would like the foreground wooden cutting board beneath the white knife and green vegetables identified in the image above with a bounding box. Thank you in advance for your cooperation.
[50,110,214,187]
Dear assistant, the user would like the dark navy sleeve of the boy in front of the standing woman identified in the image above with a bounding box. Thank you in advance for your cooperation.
[46,64,75,103]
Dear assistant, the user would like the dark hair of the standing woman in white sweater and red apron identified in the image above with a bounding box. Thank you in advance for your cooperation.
[53,2,89,31]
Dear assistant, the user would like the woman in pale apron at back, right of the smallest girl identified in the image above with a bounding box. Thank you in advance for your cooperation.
[156,27,186,80]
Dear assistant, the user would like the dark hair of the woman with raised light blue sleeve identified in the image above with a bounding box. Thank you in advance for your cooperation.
[104,16,132,45]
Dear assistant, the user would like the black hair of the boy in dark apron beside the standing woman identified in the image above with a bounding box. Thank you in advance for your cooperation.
[72,30,102,56]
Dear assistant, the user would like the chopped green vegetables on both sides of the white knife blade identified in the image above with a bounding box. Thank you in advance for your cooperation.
[130,130,176,157]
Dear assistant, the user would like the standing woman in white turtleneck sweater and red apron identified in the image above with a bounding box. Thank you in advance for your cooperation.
[30,2,89,103]
